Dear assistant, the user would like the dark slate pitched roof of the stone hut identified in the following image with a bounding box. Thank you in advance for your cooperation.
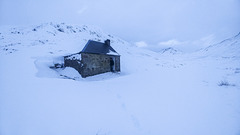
[81,40,119,55]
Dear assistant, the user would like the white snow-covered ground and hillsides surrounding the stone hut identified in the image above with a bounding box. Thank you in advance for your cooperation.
[0,23,240,135]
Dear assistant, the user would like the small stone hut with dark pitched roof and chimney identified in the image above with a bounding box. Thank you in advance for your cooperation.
[64,39,120,78]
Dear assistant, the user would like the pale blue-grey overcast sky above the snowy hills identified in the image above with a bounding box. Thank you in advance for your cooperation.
[0,0,240,47]
